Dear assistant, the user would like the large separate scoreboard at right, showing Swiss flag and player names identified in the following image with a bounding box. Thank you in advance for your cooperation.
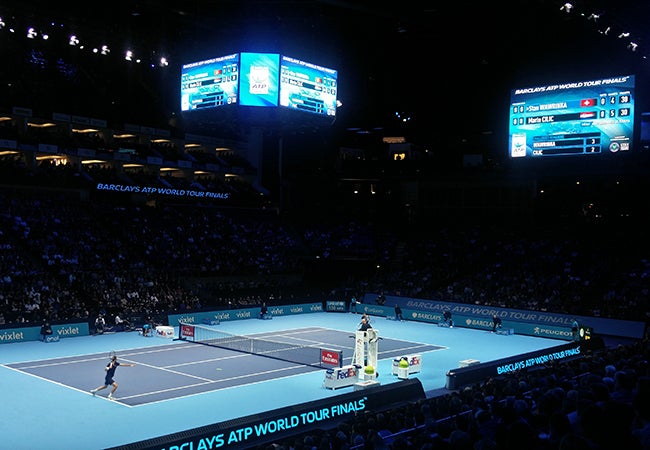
[508,75,635,159]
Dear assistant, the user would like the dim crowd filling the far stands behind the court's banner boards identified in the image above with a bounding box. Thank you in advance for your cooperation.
[0,177,650,330]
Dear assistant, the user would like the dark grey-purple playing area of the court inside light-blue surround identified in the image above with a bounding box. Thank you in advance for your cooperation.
[2,327,443,406]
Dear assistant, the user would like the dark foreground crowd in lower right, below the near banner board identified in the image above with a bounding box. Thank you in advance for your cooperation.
[253,340,650,450]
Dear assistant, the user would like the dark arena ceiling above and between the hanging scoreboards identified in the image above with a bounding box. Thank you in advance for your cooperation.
[0,0,650,141]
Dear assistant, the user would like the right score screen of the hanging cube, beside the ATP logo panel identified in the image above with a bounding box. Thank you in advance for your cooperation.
[280,55,337,116]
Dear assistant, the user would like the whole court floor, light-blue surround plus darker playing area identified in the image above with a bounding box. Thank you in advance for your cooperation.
[0,312,563,450]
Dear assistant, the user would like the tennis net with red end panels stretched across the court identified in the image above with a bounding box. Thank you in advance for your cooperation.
[179,323,343,368]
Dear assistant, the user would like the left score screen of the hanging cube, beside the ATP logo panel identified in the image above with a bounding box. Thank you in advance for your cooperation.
[180,53,239,111]
